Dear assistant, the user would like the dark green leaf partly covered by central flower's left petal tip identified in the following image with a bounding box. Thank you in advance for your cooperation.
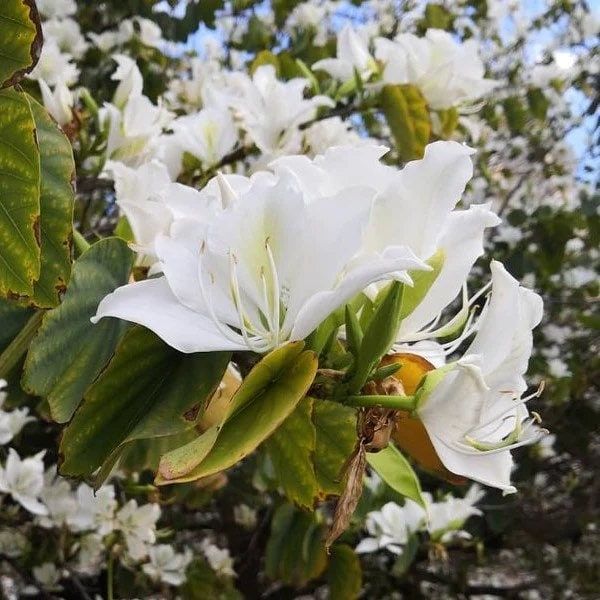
[22,238,133,423]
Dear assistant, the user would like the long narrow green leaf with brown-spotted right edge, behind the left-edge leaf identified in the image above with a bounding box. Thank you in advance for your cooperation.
[29,97,75,308]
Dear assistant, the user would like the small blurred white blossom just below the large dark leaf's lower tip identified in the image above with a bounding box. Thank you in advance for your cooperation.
[67,483,117,536]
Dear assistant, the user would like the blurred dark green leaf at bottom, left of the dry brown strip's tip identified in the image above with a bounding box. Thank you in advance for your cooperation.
[265,504,327,587]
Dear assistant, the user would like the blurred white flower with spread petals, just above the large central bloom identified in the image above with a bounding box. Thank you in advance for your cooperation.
[230,65,333,154]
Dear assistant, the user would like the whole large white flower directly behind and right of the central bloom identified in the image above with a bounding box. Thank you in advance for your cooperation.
[273,142,500,343]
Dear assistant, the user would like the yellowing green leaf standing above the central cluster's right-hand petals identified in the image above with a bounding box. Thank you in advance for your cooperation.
[381,84,431,162]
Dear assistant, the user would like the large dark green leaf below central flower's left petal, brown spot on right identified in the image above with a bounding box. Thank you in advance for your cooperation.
[60,326,231,481]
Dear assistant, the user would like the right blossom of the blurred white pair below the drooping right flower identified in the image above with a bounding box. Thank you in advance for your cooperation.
[424,485,485,542]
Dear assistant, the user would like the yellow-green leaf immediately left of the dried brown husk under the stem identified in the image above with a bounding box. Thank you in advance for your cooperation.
[312,400,356,496]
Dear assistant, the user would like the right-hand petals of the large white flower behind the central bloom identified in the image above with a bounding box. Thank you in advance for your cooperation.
[365,142,500,343]
